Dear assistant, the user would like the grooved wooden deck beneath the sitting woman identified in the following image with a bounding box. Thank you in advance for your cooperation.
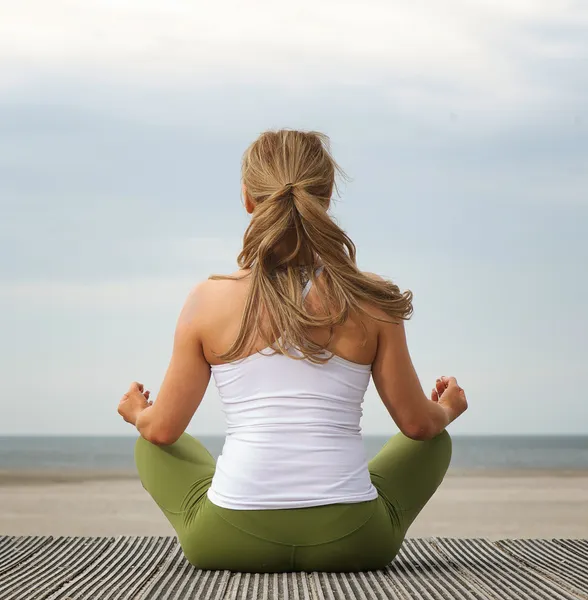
[0,536,588,600]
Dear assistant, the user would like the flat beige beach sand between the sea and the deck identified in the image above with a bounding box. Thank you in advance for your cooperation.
[0,471,588,539]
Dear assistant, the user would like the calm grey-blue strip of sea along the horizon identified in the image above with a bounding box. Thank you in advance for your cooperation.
[0,436,588,470]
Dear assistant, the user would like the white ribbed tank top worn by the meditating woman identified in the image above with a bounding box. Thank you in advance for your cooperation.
[208,267,378,510]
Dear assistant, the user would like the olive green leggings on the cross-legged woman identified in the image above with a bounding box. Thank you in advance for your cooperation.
[135,431,451,573]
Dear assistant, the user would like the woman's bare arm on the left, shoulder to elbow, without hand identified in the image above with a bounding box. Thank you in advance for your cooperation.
[135,281,210,445]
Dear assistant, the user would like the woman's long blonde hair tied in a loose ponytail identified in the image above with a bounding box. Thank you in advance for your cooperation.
[209,129,412,363]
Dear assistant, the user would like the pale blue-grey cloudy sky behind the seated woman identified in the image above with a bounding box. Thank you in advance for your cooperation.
[0,0,588,435]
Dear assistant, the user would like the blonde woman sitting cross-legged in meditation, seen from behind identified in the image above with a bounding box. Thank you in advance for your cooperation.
[118,130,467,572]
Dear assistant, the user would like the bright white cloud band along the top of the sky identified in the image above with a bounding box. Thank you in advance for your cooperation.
[0,0,588,110]
